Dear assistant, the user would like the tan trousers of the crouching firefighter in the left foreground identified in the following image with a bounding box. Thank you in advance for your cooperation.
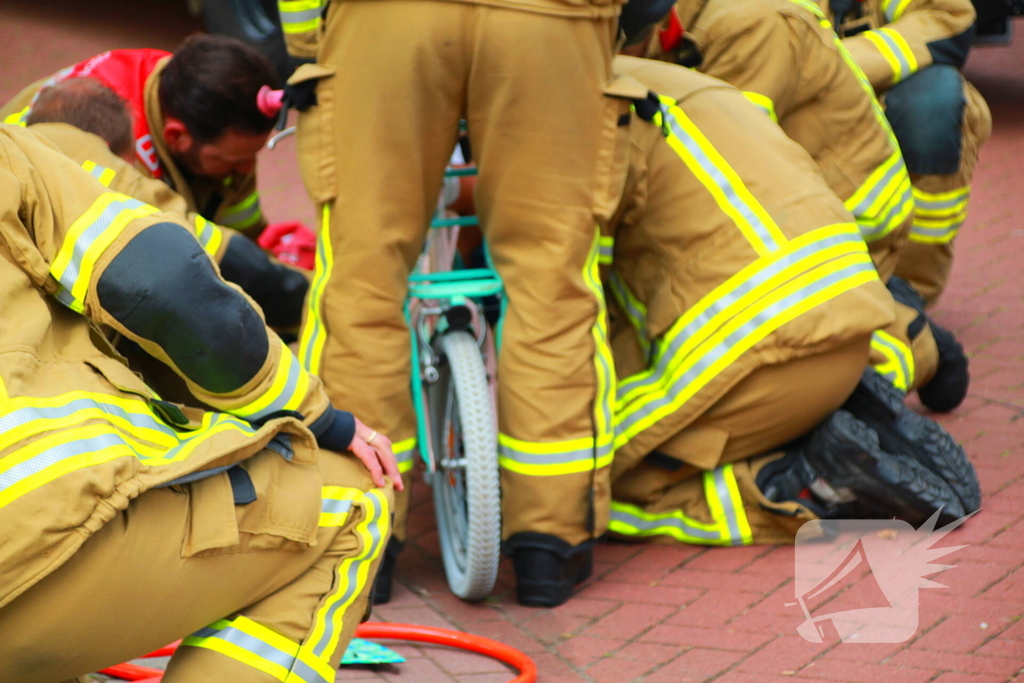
[0,451,391,683]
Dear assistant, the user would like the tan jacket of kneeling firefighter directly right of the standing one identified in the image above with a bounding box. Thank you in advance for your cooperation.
[607,57,894,477]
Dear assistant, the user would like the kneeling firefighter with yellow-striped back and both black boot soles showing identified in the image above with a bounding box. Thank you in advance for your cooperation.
[607,57,979,545]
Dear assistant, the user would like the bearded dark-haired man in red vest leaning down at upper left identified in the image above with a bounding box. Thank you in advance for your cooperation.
[0,35,276,236]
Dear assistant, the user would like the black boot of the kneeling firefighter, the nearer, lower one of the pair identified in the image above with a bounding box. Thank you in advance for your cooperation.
[801,410,965,526]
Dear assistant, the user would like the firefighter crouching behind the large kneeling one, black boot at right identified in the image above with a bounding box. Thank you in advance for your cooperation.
[644,0,969,411]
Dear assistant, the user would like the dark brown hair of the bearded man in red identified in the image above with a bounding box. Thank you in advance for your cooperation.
[159,34,276,144]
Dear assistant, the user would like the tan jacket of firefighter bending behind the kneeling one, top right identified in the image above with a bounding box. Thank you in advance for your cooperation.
[648,0,913,279]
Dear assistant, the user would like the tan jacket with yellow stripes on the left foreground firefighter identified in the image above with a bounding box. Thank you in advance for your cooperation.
[0,125,330,607]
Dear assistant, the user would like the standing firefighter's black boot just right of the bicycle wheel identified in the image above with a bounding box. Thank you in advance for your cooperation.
[504,531,594,607]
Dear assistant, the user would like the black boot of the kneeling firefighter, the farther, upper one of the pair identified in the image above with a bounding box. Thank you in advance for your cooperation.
[843,369,981,512]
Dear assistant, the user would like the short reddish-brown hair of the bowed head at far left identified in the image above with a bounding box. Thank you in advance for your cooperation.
[26,78,134,157]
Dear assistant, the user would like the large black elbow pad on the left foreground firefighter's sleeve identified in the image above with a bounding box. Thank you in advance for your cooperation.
[96,222,269,393]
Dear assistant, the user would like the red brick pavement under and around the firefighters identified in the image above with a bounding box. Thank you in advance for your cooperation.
[0,5,1024,683]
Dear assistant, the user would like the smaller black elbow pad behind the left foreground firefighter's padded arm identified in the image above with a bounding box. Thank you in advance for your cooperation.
[220,234,309,329]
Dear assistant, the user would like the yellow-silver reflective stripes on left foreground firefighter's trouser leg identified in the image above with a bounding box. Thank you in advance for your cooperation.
[182,486,389,683]
